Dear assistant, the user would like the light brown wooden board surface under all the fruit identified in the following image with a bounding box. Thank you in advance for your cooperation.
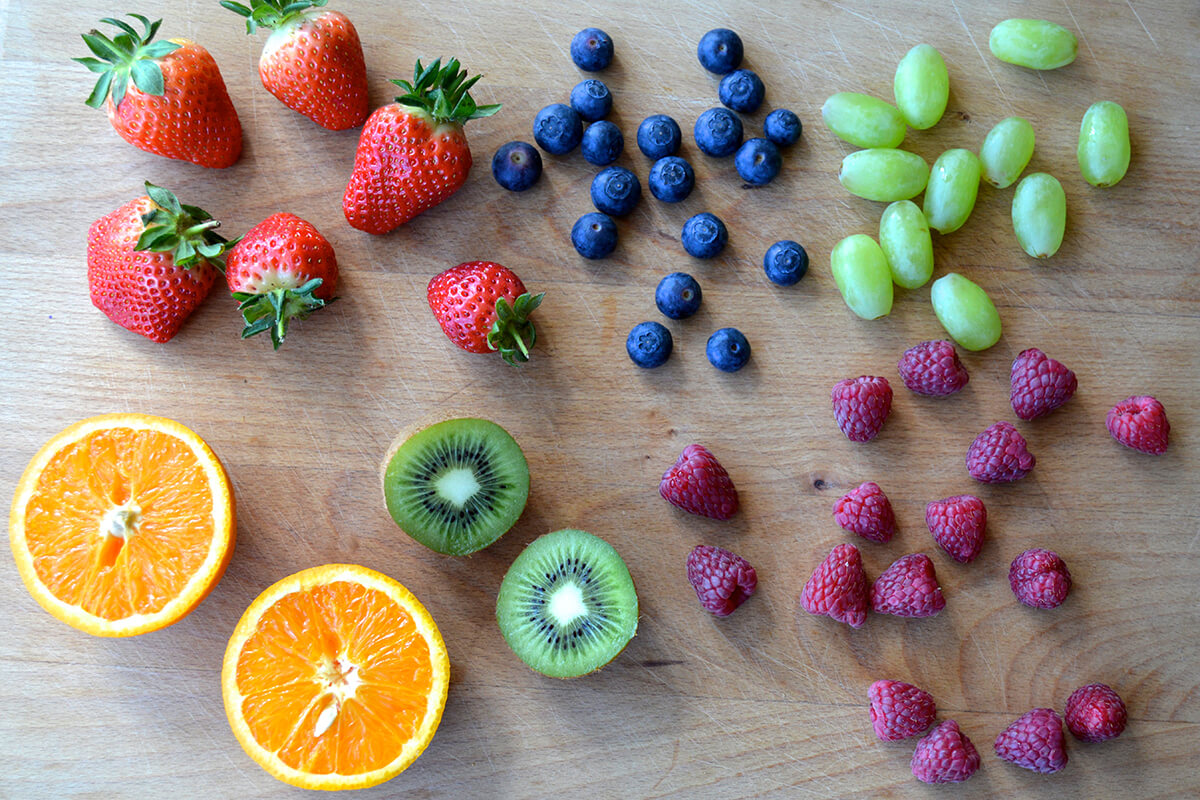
[0,0,1200,799]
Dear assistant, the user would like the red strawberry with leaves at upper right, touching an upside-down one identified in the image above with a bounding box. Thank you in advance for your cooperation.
[88,182,228,342]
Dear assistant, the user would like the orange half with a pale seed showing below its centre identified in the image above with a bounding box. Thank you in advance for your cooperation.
[221,564,450,789]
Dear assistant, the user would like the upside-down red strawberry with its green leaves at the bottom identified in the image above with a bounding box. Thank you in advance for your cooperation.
[226,213,337,350]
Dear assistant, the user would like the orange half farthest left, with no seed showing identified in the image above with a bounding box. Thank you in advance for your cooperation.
[8,414,236,636]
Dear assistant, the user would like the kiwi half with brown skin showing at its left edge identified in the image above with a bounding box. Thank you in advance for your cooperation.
[383,417,529,555]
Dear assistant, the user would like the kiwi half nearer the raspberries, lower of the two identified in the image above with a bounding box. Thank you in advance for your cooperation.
[496,529,637,678]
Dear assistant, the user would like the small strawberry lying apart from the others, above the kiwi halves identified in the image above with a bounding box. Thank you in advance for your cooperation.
[426,261,545,365]
